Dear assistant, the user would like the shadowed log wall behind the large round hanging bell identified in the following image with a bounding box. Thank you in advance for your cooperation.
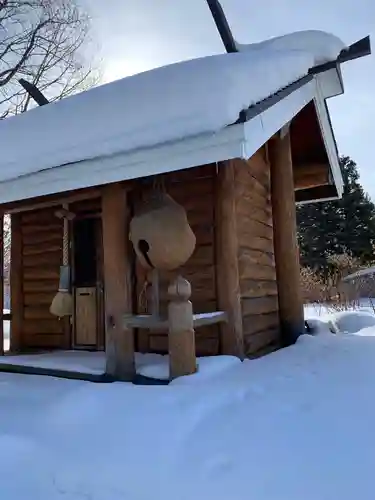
[136,165,219,356]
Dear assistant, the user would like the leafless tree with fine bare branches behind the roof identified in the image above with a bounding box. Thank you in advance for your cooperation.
[0,0,100,119]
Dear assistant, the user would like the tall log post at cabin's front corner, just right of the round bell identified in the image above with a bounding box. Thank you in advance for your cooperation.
[215,161,244,359]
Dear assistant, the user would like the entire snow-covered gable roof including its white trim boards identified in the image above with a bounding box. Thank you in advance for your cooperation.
[0,32,372,203]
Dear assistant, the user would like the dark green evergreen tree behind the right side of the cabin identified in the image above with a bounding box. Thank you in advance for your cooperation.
[297,156,375,270]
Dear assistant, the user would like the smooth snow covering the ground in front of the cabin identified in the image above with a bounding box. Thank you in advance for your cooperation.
[0,313,375,500]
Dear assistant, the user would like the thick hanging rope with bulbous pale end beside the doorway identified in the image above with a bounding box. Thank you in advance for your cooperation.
[49,205,74,318]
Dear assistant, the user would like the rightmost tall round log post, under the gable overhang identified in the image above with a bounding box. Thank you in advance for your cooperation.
[269,129,304,345]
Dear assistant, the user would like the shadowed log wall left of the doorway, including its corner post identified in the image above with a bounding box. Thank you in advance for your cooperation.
[11,207,70,350]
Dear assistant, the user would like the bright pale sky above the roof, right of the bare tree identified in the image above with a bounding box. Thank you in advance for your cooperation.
[86,0,375,199]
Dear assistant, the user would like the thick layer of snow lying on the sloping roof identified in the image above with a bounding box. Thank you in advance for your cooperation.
[0,28,340,181]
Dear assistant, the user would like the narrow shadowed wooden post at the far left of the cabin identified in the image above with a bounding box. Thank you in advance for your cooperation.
[9,214,24,352]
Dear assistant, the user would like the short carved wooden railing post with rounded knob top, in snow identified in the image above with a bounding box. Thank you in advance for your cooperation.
[168,276,197,380]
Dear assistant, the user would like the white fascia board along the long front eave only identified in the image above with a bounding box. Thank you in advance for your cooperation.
[0,124,244,203]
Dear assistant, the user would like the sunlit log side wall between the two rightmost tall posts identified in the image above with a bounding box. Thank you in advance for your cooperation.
[236,148,280,357]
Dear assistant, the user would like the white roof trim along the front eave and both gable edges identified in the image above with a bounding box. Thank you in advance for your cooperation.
[0,71,343,203]
